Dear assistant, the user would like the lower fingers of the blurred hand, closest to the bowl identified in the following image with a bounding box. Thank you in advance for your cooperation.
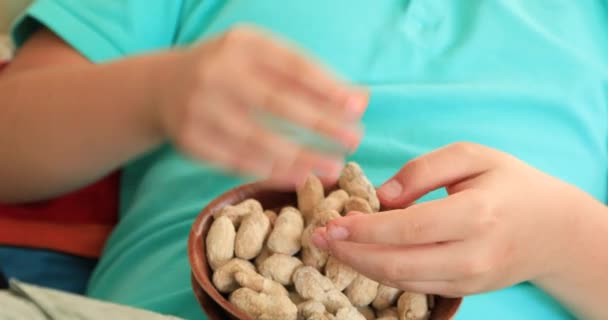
[200,94,342,187]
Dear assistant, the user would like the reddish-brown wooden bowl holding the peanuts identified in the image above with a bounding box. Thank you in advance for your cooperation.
[188,183,462,320]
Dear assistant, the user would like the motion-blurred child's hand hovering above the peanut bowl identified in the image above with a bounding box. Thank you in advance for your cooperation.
[159,27,367,186]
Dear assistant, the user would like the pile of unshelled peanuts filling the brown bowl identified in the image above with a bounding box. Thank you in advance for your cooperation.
[206,162,434,320]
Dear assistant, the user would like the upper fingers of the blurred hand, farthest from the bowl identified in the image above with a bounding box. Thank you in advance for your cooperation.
[219,27,368,147]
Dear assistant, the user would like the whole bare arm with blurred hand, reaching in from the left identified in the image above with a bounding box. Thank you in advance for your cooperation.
[0,26,367,203]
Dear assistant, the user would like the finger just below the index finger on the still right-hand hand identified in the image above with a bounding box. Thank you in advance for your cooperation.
[329,241,463,283]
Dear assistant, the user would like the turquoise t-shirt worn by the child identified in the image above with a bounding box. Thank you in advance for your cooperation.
[15,0,608,320]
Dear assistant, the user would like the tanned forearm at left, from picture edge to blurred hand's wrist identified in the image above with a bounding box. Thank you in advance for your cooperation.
[0,53,174,202]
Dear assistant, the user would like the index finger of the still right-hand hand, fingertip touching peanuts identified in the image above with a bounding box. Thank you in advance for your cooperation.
[324,191,478,246]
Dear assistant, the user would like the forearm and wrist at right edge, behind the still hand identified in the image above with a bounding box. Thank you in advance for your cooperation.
[535,196,608,319]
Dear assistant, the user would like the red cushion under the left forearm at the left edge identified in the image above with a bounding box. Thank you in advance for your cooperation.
[0,173,119,258]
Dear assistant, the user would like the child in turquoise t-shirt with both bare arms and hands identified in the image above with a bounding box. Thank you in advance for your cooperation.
[0,0,608,319]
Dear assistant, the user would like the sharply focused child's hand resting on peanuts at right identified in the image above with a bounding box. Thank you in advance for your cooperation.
[313,143,601,296]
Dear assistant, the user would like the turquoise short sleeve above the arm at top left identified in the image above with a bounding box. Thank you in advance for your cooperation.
[13,0,182,63]
